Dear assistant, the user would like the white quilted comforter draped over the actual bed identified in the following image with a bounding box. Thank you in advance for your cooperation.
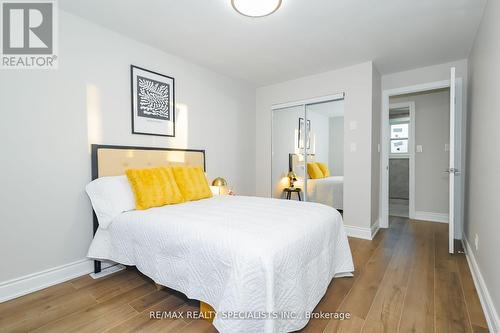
[88,196,354,333]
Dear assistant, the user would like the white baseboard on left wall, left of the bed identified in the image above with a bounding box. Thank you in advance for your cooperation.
[0,258,113,303]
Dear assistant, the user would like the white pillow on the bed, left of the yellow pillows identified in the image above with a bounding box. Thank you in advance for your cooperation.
[85,176,135,229]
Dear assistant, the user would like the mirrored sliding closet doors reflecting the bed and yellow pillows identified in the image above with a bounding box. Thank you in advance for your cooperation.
[272,94,344,211]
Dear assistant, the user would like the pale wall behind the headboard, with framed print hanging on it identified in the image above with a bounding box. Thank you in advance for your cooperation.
[0,11,255,281]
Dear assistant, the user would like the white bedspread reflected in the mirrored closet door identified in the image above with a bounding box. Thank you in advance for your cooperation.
[307,176,344,209]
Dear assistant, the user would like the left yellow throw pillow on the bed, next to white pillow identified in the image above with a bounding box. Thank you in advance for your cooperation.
[125,167,184,210]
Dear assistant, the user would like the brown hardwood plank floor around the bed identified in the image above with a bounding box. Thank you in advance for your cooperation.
[0,218,488,333]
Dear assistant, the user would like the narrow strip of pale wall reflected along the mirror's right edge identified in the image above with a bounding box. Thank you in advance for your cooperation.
[328,117,344,176]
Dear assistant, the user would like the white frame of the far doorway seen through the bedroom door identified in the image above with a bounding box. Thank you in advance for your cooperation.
[387,101,415,219]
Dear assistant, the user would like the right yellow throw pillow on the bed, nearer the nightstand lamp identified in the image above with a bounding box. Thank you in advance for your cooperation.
[173,167,212,201]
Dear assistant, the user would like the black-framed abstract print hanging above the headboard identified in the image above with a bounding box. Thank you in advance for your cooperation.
[130,65,176,137]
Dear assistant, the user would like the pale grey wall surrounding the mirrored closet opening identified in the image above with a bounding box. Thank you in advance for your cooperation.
[255,62,380,228]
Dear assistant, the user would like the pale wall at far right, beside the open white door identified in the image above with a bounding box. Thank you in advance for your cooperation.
[465,0,500,326]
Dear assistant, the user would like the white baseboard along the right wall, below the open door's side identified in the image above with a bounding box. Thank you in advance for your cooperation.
[462,235,500,333]
